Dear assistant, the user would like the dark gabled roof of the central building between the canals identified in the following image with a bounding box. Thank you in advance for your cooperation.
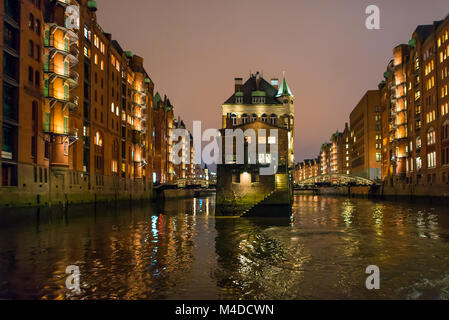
[224,74,282,105]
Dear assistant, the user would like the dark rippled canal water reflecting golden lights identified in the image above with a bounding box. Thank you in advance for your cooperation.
[0,194,449,299]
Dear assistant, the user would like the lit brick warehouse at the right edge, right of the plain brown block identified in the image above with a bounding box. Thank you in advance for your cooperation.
[379,16,449,196]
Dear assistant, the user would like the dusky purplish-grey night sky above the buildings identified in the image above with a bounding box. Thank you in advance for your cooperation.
[97,0,449,161]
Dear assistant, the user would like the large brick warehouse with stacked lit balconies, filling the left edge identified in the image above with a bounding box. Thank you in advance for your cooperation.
[0,0,175,206]
